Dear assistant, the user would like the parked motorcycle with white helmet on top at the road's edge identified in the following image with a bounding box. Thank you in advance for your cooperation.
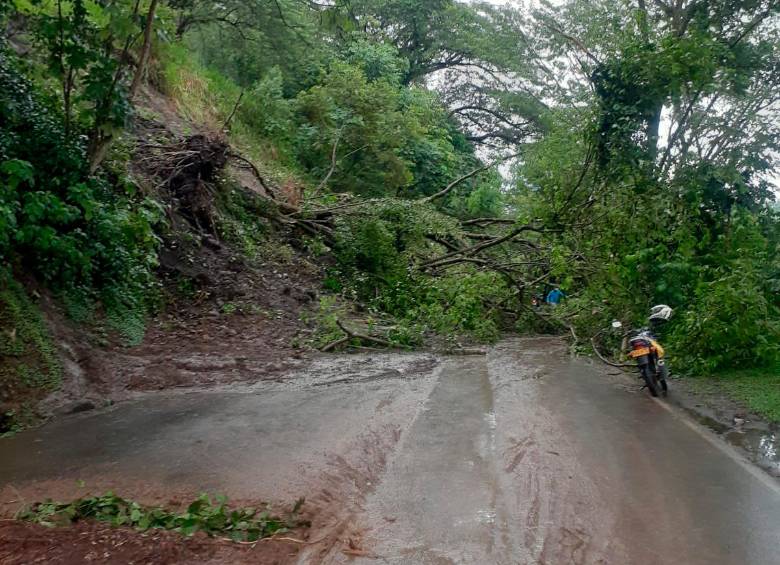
[612,305,672,396]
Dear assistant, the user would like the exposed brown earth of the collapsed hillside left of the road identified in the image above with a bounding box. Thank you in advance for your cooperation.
[0,83,330,431]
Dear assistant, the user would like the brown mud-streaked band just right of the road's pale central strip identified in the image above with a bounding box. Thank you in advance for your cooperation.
[488,338,618,565]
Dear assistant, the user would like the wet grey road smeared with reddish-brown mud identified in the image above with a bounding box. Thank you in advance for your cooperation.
[0,339,780,565]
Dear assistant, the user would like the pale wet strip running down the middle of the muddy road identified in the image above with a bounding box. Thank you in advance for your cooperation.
[323,357,514,564]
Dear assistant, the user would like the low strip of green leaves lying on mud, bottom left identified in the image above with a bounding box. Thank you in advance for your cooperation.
[17,492,303,542]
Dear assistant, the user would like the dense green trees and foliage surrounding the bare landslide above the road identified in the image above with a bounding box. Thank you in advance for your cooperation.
[0,0,780,414]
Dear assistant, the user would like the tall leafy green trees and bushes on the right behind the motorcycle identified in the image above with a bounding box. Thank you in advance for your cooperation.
[513,0,780,374]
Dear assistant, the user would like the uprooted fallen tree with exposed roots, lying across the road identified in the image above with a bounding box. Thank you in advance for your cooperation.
[137,135,553,351]
